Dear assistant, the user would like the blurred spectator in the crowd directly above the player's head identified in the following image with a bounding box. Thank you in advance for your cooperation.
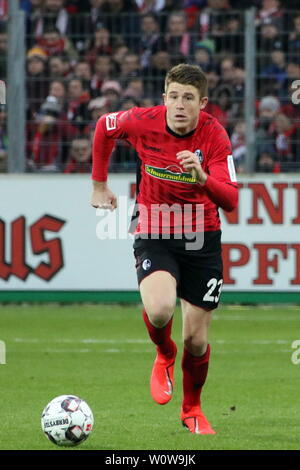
[165,11,193,61]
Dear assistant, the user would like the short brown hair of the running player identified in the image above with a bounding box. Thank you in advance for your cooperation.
[165,64,207,98]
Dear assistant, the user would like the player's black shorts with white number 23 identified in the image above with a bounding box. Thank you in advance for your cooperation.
[133,230,223,310]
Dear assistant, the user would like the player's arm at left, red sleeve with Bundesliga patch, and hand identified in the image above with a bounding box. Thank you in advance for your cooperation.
[91,110,138,210]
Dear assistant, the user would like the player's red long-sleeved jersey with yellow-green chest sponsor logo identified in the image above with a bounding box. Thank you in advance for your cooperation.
[92,105,238,233]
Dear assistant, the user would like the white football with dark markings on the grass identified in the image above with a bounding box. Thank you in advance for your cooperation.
[41,395,94,446]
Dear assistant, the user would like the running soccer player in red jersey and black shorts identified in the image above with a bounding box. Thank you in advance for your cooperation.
[91,64,238,434]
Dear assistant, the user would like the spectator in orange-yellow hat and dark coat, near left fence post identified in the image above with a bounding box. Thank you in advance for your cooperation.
[26,47,48,113]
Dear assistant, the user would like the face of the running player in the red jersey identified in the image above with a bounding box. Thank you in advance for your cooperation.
[163,82,207,135]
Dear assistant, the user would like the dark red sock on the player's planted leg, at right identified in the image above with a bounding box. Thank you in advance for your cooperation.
[181,344,210,413]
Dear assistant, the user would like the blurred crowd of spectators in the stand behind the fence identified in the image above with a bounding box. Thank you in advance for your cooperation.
[0,0,300,173]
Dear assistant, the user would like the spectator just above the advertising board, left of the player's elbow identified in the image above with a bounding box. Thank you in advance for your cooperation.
[64,136,92,173]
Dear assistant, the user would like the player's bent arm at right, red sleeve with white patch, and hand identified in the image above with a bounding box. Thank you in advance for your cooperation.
[177,126,238,212]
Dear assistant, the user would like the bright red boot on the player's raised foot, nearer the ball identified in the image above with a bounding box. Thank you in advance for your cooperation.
[150,342,177,405]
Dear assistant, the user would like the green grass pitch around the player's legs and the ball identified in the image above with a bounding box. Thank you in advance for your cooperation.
[0,305,300,451]
